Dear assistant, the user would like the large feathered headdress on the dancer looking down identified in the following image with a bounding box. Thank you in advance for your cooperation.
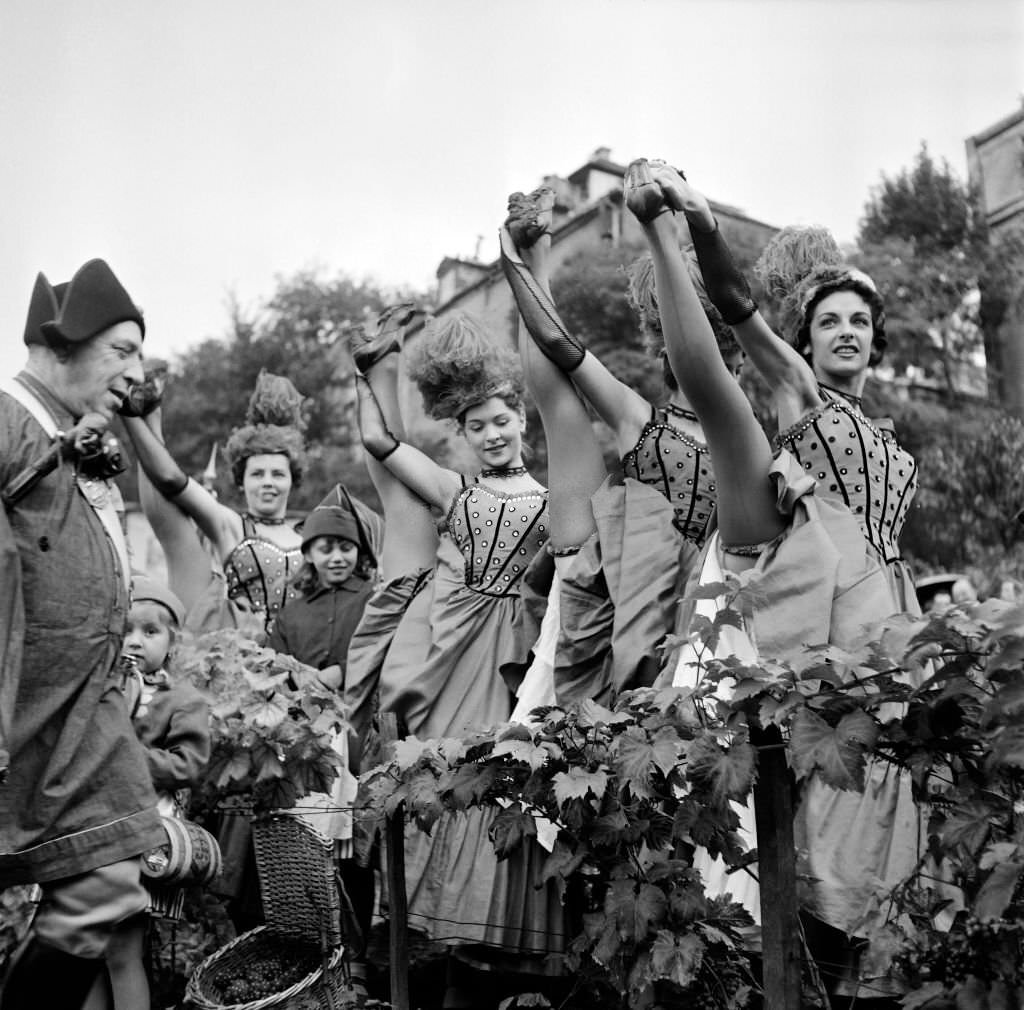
[409,314,523,423]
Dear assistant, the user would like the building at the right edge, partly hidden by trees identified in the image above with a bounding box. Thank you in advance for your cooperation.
[967,103,1024,409]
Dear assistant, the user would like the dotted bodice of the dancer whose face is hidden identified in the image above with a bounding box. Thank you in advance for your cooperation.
[623,409,715,544]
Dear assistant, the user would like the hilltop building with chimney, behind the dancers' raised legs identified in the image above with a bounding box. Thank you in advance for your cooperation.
[402,148,776,466]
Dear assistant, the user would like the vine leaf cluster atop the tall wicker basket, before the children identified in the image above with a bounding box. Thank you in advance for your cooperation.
[177,629,348,811]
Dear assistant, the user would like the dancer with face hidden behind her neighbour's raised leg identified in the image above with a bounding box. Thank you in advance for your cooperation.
[501,190,742,704]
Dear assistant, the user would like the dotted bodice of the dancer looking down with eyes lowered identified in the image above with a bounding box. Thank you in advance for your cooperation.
[447,483,548,596]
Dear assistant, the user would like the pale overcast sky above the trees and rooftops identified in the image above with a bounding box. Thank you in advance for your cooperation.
[0,0,1024,374]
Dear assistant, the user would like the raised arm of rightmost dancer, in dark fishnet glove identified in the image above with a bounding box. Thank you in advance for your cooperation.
[652,165,821,412]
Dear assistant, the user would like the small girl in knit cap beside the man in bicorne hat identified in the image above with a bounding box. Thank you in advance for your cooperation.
[84,576,211,1010]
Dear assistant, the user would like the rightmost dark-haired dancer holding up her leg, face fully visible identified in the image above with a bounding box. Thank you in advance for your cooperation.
[626,162,926,1002]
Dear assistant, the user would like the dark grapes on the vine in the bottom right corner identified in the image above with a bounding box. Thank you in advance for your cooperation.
[897,916,1024,987]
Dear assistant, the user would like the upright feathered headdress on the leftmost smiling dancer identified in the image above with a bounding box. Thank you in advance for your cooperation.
[224,369,306,488]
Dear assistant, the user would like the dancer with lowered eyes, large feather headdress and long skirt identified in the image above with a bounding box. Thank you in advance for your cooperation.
[356,317,562,950]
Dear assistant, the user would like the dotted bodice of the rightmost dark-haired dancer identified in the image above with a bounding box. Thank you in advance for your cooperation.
[777,397,918,563]
